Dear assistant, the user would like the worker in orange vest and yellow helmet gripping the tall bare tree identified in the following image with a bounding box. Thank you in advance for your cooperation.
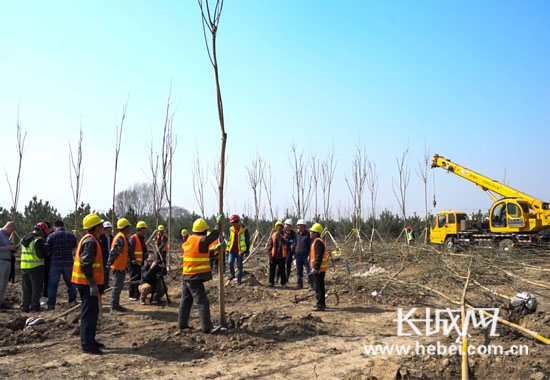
[178,215,223,333]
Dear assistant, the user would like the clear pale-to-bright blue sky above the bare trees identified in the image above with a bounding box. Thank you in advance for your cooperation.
[0,0,550,220]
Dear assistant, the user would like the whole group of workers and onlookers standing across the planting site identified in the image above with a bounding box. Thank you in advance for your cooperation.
[0,214,327,354]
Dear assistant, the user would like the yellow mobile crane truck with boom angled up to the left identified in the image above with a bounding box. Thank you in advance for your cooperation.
[430,154,550,251]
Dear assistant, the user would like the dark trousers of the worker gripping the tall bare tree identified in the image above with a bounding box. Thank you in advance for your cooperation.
[178,280,216,332]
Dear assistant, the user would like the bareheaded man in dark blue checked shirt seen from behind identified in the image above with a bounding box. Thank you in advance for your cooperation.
[46,220,77,310]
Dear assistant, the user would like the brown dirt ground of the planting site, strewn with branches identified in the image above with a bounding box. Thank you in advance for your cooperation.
[0,244,550,380]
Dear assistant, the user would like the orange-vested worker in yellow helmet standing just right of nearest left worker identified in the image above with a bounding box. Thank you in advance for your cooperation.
[107,218,131,313]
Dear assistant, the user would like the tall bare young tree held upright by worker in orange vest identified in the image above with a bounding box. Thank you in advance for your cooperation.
[198,0,227,326]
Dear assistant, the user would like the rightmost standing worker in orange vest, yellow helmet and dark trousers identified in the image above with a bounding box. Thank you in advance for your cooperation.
[309,223,328,311]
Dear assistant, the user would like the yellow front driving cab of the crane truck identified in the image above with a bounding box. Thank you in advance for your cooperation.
[430,211,468,252]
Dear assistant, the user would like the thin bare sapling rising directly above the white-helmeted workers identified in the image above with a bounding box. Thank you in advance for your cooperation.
[290,143,313,218]
